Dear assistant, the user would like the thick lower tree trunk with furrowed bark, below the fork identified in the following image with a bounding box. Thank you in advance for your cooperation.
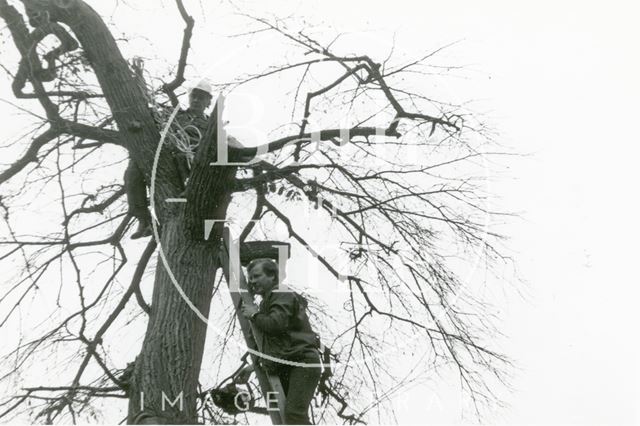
[128,220,219,424]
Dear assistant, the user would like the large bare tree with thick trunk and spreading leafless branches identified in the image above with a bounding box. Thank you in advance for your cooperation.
[0,0,508,423]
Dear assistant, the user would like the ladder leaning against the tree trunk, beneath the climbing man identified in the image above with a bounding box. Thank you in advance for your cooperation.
[220,227,285,424]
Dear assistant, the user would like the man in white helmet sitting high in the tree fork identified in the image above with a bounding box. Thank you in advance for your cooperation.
[124,80,242,239]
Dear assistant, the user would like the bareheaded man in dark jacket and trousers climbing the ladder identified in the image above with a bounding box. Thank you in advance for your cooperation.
[242,259,321,424]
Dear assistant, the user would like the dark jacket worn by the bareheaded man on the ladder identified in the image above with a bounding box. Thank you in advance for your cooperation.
[252,291,320,364]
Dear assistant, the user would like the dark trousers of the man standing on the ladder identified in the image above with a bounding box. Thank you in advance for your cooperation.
[278,359,322,425]
